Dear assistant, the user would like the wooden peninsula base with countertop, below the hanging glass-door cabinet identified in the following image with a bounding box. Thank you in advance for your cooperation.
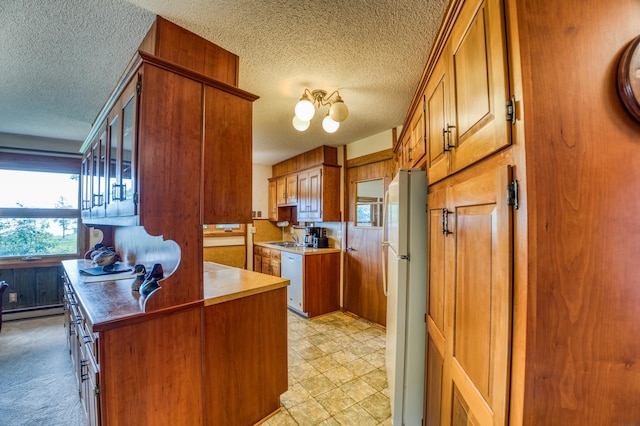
[63,260,289,425]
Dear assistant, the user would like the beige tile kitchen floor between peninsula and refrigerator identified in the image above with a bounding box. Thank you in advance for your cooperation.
[263,312,391,426]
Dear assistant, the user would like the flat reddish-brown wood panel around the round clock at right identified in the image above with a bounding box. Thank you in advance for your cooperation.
[509,0,640,425]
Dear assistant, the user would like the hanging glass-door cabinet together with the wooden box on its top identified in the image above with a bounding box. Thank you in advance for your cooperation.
[81,18,257,231]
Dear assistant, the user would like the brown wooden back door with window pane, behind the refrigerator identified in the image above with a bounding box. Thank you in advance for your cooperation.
[343,150,395,326]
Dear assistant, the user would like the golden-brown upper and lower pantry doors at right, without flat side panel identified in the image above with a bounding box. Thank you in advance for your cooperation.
[398,0,513,425]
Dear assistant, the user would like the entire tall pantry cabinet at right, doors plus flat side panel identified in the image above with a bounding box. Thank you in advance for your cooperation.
[404,0,640,425]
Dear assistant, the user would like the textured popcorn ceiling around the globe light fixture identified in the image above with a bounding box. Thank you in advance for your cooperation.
[0,0,448,164]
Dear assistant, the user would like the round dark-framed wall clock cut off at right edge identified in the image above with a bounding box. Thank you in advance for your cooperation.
[618,36,640,122]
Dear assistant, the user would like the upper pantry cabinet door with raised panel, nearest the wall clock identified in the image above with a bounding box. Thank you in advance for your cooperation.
[449,0,511,172]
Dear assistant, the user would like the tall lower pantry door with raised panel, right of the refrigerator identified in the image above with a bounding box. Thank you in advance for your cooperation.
[440,167,513,426]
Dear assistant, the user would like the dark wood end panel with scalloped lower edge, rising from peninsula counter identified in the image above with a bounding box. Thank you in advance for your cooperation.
[138,64,203,310]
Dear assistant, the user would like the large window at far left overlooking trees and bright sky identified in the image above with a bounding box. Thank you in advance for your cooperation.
[0,154,81,260]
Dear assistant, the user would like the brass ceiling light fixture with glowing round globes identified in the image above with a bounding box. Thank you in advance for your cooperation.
[293,89,349,133]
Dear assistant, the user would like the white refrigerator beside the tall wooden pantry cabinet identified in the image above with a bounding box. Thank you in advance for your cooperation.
[382,169,427,426]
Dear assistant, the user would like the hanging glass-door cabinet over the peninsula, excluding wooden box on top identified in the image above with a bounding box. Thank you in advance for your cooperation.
[82,56,256,233]
